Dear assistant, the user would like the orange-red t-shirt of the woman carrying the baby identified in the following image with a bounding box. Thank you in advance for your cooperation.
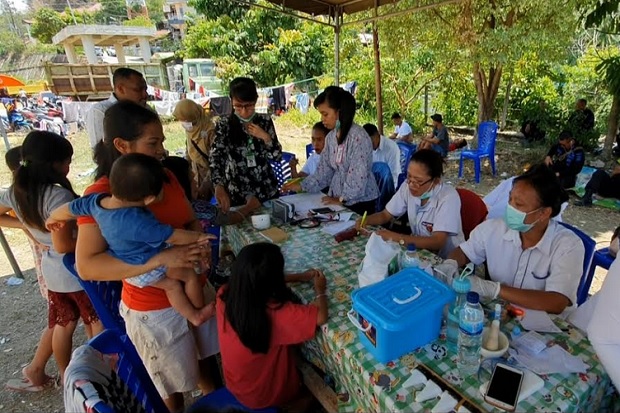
[77,169,194,311]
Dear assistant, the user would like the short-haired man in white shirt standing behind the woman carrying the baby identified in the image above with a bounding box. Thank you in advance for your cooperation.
[86,67,148,149]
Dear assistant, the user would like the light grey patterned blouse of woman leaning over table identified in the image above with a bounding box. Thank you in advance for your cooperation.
[301,123,379,205]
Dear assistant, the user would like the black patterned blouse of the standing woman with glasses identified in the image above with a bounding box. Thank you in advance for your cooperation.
[209,114,282,206]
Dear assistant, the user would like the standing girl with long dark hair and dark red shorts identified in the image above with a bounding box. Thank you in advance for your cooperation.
[0,131,102,377]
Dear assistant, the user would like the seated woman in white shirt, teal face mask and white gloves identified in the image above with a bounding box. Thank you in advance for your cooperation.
[450,165,585,314]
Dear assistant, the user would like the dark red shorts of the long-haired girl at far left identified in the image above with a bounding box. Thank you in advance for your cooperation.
[47,290,99,328]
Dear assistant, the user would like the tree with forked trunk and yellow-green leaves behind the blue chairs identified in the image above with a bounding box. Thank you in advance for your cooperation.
[385,0,576,130]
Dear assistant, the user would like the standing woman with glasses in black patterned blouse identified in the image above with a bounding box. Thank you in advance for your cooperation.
[209,77,282,213]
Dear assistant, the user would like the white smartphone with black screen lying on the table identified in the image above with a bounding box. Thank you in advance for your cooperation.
[484,363,523,412]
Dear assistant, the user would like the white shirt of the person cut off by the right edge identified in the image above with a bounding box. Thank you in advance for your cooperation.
[588,254,620,389]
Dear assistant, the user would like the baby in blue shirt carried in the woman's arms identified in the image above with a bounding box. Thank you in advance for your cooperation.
[46,153,215,326]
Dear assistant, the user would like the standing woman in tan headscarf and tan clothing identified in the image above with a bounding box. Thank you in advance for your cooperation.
[172,99,215,199]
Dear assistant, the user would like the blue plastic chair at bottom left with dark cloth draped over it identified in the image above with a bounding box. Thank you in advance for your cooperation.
[66,330,169,413]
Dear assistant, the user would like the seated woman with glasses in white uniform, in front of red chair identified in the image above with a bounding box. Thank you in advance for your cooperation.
[356,149,464,258]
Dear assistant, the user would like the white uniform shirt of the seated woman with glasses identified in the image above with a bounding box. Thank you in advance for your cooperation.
[385,183,465,258]
